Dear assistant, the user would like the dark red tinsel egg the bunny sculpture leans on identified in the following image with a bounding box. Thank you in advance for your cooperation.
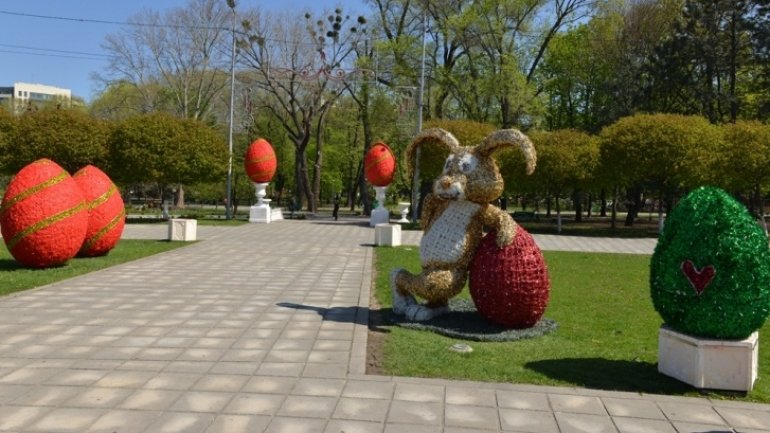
[469,226,551,329]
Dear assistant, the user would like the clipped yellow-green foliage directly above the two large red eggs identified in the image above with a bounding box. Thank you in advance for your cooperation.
[4,109,110,173]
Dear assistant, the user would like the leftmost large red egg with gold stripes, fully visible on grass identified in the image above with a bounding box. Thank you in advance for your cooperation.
[0,159,88,268]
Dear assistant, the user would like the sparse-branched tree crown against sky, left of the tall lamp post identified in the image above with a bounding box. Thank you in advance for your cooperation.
[97,0,231,119]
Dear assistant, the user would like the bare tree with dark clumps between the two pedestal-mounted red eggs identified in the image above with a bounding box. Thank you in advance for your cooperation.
[238,5,366,212]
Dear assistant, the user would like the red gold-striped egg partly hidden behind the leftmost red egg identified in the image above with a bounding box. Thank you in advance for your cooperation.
[72,165,126,257]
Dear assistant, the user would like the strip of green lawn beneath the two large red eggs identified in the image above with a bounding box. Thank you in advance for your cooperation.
[0,239,189,295]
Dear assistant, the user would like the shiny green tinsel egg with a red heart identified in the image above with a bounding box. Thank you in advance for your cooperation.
[650,187,770,340]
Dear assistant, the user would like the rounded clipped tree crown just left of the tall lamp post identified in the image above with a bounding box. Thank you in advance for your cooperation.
[109,113,227,184]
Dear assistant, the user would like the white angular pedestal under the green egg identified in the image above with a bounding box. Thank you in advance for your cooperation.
[658,326,759,392]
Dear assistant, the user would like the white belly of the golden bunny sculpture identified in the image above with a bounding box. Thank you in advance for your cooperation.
[420,201,481,266]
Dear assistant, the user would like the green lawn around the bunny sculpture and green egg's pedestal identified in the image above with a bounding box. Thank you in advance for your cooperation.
[376,247,770,402]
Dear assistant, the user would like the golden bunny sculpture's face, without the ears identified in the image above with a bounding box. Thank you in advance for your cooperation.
[433,148,503,203]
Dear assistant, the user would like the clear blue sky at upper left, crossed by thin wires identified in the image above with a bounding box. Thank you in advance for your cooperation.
[0,0,367,101]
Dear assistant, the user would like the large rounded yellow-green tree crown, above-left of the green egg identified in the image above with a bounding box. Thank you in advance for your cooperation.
[600,114,721,191]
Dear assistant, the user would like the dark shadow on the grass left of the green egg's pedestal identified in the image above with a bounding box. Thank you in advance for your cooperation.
[524,358,695,394]
